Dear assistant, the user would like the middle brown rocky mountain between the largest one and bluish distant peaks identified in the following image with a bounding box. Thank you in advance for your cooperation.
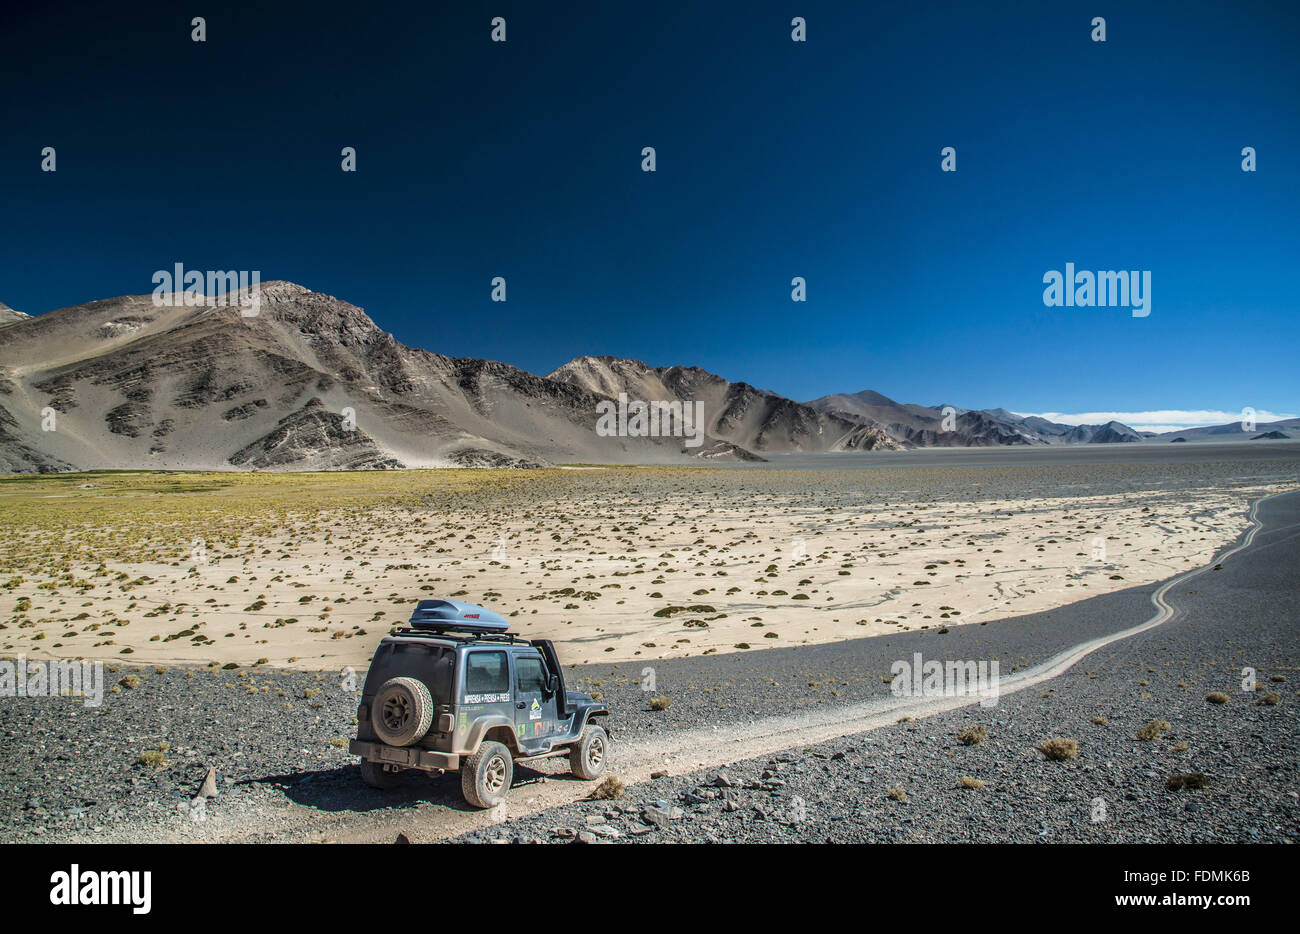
[546,356,902,453]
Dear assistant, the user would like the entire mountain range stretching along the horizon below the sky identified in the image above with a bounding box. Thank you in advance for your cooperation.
[0,281,1268,472]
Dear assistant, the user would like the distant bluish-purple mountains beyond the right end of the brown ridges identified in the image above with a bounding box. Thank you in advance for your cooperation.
[805,389,1141,447]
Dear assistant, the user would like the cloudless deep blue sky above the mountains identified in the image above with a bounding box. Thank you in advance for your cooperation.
[0,0,1300,412]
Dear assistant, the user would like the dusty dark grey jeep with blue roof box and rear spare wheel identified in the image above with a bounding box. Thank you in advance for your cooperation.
[347,600,610,808]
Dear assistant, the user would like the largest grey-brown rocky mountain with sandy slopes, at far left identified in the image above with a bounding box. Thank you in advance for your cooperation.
[0,282,754,472]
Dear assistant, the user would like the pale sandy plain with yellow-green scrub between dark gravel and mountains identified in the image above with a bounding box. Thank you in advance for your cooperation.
[0,457,1300,670]
